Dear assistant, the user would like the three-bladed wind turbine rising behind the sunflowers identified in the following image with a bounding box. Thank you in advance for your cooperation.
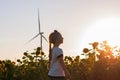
[28,9,48,52]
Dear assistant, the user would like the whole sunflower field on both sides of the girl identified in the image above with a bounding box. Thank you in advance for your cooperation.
[0,41,120,80]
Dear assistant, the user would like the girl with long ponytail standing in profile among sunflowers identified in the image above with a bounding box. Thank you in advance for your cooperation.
[48,30,70,80]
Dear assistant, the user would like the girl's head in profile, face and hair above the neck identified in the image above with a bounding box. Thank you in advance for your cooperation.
[49,30,63,45]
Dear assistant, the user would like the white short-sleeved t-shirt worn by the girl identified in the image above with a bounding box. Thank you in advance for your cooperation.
[48,47,65,77]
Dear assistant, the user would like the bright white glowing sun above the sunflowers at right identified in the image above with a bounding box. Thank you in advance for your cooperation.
[81,17,120,55]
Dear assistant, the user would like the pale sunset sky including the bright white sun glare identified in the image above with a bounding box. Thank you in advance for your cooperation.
[0,0,120,60]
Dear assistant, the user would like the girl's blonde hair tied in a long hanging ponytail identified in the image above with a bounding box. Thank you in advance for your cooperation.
[49,30,61,61]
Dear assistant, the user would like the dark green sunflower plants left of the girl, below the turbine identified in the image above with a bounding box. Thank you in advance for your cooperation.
[0,47,48,80]
